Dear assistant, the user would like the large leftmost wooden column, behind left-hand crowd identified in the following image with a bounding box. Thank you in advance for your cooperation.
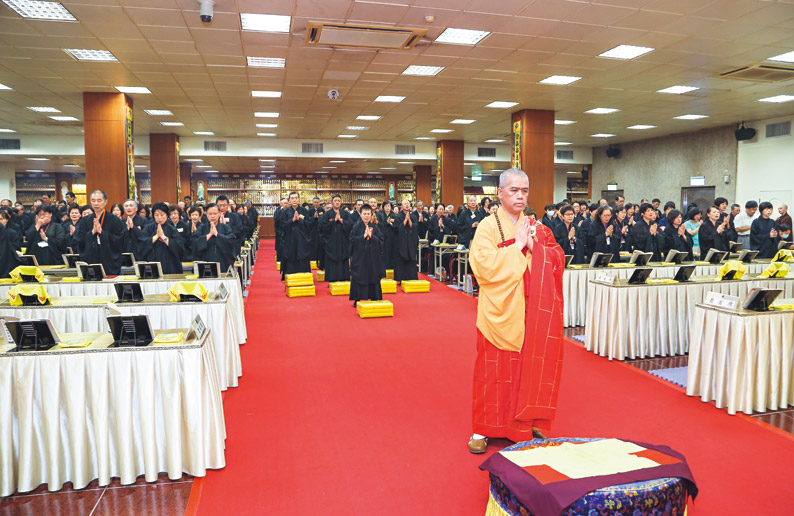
[83,92,135,206]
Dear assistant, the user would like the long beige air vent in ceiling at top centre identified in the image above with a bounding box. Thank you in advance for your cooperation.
[306,22,427,50]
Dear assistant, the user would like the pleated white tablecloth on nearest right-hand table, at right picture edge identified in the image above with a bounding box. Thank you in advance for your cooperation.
[686,305,794,414]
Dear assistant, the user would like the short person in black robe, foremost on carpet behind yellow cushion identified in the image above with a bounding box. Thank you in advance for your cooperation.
[350,204,386,306]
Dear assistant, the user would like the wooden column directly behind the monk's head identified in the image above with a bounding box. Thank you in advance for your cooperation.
[512,109,554,214]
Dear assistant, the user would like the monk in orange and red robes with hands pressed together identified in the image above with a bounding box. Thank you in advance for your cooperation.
[469,169,565,453]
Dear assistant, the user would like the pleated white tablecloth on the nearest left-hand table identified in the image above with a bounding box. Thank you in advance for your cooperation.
[0,335,226,496]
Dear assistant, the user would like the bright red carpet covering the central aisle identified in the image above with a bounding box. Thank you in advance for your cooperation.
[198,241,794,516]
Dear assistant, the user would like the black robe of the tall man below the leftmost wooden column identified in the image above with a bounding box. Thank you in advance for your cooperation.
[78,212,124,276]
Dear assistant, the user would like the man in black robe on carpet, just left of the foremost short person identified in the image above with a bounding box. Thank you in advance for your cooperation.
[319,195,353,282]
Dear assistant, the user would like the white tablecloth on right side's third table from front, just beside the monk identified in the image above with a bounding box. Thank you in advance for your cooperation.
[562,263,769,328]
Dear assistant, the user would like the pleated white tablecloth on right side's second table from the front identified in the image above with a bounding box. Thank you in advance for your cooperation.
[585,278,794,360]
